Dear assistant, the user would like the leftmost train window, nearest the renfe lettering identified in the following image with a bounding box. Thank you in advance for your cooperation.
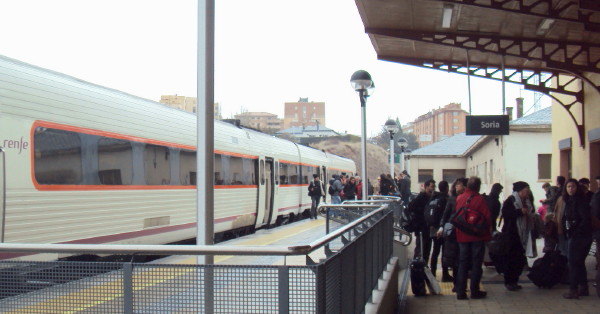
[33,127,82,184]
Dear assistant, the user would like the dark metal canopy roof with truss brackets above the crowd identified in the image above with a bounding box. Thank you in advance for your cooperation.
[355,0,600,146]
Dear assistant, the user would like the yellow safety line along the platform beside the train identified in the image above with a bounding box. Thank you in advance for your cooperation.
[4,219,325,313]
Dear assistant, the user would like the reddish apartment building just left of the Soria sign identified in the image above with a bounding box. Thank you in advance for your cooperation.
[411,103,467,147]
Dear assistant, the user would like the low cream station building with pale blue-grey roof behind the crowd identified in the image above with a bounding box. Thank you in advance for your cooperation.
[409,107,553,200]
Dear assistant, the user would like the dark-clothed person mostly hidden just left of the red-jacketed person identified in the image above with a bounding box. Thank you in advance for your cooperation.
[437,178,467,292]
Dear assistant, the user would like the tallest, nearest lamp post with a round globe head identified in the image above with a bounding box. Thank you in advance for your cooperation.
[350,70,375,200]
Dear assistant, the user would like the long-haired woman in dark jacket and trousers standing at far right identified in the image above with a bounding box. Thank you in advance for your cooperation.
[561,179,592,299]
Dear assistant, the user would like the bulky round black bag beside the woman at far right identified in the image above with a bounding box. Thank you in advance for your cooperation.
[527,250,567,288]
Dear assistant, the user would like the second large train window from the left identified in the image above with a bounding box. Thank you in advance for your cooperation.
[98,137,133,185]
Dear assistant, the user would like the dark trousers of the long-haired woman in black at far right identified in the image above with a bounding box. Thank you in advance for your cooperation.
[567,238,592,290]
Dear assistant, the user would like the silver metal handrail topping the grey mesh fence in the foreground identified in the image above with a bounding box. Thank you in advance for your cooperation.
[0,205,387,256]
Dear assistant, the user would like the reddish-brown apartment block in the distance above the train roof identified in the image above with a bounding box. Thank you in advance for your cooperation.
[283,98,325,129]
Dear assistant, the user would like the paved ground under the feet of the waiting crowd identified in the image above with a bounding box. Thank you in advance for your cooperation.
[405,239,600,314]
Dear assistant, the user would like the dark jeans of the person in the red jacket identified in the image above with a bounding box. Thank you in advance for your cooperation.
[456,241,485,294]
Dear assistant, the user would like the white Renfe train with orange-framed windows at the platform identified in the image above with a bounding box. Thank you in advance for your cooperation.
[0,56,356,259]
